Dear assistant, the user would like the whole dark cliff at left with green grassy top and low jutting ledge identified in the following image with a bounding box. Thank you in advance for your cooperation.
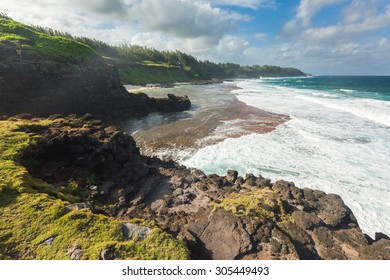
[0,17,191,117]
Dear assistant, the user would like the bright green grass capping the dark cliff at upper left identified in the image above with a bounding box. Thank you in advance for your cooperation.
[0,18,96,61]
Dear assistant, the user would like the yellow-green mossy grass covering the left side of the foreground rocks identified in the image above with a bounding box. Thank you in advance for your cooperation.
[0,119,189,259]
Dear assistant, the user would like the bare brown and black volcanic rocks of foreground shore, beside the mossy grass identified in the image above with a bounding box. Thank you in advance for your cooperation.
[0,114,390,260]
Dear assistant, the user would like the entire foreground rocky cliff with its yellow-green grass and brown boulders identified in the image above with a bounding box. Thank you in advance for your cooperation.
[0,115,390,259]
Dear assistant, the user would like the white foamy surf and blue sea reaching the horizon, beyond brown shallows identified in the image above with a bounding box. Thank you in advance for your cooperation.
[120,76,390,236]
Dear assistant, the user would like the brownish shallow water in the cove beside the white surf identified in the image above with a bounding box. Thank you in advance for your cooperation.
[116,83,289,161]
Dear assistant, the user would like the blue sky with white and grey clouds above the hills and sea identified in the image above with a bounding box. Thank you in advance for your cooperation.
[0,0,390,75]
